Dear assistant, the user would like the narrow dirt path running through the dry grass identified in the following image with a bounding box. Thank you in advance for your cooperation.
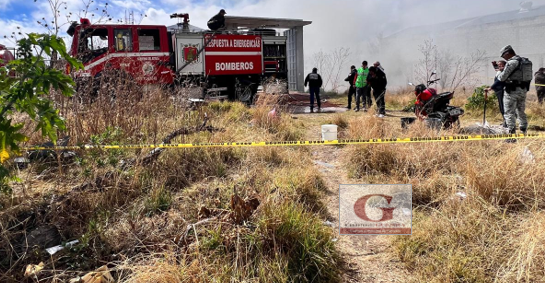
[300,115,409,282]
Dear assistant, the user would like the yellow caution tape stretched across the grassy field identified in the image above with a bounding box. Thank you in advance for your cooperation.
[23,134,545,150]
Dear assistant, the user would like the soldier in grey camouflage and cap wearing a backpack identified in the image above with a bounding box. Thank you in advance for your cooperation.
[497,45,528,136]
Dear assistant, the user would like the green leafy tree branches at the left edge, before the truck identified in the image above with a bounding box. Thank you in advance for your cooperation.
[0,33,83,191]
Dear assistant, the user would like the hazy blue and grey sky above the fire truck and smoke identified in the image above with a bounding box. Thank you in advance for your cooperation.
[0,0,545,85]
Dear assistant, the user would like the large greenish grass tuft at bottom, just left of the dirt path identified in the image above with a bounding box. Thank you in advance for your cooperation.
[254,202,339,282]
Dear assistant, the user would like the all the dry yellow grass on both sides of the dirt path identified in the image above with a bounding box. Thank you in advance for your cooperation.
[0,80,545,282]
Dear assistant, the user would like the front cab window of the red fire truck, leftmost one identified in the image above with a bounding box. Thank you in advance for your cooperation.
[78,28,108,63]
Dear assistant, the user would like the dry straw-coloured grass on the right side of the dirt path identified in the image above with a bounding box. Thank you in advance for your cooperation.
[344,108,545,282]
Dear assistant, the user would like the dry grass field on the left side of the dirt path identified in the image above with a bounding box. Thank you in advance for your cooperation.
[0,84,340,282]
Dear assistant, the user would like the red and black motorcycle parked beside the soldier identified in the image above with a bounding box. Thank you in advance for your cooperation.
[409,71,464,129]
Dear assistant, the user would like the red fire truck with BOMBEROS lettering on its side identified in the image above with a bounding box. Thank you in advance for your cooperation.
[68,14,311,100]
